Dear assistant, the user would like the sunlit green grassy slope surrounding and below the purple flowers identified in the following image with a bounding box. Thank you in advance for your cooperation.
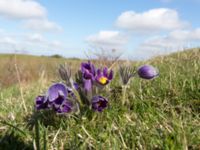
[0,49,200,150]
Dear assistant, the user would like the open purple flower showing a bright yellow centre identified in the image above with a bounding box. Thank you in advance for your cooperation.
[95,67,113,86]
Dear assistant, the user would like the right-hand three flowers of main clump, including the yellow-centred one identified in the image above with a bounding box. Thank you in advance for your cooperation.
[76,61,113,112]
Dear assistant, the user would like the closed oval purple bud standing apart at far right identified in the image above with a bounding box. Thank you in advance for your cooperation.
[138,65,158,79]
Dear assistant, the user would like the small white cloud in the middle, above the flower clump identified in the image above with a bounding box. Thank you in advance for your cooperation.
[86,31,128,49]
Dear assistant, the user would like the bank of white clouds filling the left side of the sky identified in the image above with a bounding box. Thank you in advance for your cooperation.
[0,0,63,52]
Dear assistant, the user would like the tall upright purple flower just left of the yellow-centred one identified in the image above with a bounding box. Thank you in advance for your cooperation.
[81,61,96,91]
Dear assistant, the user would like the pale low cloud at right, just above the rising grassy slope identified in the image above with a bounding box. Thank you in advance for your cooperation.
[134,28,200,58]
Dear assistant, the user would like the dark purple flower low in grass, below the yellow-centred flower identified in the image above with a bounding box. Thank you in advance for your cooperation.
[92,96,108,112]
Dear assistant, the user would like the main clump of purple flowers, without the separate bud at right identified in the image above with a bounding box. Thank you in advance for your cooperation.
[35,61,113,114]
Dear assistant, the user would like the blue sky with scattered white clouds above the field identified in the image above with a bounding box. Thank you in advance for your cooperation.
[0,0,200,60]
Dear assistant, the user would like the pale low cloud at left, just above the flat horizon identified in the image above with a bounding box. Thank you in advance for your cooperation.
[0,33,64,54]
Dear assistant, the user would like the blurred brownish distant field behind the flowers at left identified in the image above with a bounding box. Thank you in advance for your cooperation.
[0,54,80,87]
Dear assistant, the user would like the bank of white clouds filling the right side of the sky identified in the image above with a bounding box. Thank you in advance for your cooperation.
[87,8,200,59]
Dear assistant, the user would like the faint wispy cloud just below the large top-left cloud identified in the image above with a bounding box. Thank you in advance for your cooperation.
[24,19,62,32]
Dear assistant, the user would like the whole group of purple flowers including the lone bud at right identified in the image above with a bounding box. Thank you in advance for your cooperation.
[35,61,158,114]
